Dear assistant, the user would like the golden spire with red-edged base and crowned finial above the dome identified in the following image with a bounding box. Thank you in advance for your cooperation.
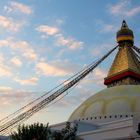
[104,21,140,87]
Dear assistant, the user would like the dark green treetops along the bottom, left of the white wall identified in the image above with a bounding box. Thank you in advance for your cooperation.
[11,122,77,140]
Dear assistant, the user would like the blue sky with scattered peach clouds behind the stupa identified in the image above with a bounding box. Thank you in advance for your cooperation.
[0,0,140,124]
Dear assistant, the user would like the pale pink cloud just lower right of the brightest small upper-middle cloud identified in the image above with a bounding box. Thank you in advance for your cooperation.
[56,34,84,50]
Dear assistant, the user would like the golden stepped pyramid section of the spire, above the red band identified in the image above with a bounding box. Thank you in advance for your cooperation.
[107,44,140,78]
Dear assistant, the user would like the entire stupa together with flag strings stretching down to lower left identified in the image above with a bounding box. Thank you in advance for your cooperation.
[0,21,140,140]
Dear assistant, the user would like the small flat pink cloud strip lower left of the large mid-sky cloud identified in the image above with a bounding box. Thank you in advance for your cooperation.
[14,77,38,85]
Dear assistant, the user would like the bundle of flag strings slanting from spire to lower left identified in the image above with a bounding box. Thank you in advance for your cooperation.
[0,46,118,133]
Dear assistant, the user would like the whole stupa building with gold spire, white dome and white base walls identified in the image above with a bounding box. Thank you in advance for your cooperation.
[52,21,140,140]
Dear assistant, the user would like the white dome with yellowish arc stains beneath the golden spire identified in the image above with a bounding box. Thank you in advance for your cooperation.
[69,85,140,122]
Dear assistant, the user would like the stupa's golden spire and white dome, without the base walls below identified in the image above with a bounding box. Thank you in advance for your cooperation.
[69,21,140,124]
